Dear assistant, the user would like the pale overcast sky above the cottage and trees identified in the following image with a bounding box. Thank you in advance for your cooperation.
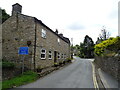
[0,0,119,45]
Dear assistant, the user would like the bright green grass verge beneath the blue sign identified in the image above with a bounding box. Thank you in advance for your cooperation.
[2,71,38,89]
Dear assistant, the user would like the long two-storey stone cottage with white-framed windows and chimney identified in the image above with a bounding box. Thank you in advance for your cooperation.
[2,3,70,69]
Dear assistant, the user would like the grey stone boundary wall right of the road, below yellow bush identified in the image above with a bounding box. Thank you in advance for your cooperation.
[95,56,120,80]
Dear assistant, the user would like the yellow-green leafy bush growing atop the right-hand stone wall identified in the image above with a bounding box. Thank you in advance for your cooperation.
[94,37,120,56]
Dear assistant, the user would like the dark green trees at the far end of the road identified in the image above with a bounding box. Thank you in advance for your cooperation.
[72,35,94,58]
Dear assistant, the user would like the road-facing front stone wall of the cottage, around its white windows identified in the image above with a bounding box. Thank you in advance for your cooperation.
[35,19,70,68]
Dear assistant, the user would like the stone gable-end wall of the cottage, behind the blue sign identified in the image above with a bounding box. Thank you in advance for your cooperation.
[2,14,35,68]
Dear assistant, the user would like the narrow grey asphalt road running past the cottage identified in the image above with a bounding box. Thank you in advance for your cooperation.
[18,57,94,88]
